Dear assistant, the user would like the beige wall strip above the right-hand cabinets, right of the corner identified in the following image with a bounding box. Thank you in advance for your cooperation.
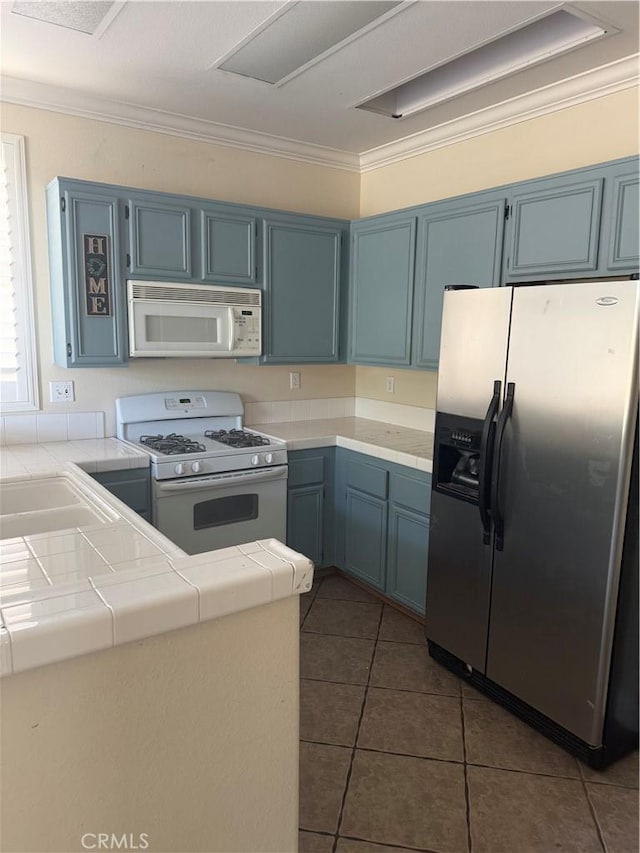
[360,88,640,216]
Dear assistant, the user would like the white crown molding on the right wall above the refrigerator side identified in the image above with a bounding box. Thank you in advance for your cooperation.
[360,54,640,174]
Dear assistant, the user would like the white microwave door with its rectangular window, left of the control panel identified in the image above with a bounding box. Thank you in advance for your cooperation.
[129,298,233,358]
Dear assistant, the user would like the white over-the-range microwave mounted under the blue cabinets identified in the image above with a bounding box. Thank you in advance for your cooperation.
[127,281,262,358]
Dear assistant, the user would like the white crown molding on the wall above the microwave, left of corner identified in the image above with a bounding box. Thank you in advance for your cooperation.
[0,77,360,172]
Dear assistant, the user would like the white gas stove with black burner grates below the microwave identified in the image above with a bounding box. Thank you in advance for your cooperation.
[116,391,287,554]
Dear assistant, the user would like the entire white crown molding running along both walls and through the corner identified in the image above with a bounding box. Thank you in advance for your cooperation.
[0,54,640,174]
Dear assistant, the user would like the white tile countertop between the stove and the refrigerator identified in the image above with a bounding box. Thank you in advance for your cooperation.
[249,418,433,472]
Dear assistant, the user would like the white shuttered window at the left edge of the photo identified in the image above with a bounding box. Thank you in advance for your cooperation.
[0,133,38,412]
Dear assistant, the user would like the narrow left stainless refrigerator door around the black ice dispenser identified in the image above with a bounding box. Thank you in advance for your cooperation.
[425,287,513,672]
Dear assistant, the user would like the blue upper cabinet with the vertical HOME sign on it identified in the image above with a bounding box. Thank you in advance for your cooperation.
[47,179,127,367]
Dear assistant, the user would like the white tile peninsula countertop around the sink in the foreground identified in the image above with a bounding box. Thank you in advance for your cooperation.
[0,452,313,676]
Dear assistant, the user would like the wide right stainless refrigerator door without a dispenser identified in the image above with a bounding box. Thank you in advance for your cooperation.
[487,281,638,746]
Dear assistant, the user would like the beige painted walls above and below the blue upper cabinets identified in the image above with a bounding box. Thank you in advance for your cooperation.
[2,89,640,422]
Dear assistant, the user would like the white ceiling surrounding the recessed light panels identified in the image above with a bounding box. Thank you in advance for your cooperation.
[0,0,639,168]
